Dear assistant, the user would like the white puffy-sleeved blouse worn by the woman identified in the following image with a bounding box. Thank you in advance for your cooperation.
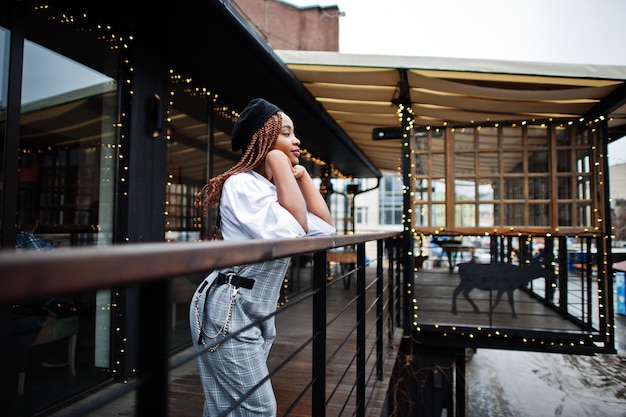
[220,171,336,240]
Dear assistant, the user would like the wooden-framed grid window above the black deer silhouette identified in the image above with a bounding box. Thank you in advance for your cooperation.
[414,124,598,229]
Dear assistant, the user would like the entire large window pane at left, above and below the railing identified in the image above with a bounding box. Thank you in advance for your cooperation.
[12,24,120,415]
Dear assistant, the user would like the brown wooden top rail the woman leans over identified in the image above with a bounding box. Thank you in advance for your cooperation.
[0,232,399,304]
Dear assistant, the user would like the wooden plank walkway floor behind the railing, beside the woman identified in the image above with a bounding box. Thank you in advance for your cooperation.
[54,267,394,417]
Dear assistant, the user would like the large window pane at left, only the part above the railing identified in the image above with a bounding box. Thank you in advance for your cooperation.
[17,42,117,246]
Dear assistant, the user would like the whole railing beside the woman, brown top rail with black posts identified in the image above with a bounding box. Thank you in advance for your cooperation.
[0,233,402,417]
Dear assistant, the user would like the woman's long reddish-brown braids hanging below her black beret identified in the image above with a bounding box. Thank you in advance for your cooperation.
[196,113,283,211]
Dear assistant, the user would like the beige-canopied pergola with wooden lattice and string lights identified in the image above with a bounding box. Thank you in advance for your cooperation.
[277,51,626,351]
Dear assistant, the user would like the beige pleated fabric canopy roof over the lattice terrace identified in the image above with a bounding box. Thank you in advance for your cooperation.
[275,50,626,174]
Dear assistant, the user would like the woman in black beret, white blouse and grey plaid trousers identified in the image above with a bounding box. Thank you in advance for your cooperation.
[189,99,335,417]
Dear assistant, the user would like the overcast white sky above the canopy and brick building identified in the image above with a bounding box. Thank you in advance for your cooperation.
[281,0,626,164]
